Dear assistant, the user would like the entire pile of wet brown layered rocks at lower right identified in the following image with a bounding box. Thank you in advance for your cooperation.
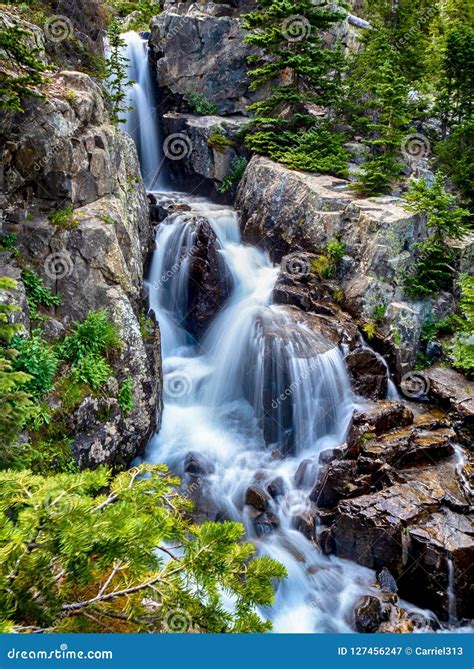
[310,402,474,631]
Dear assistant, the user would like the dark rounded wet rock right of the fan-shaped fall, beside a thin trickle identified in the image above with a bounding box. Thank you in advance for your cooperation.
[346,347,388,400]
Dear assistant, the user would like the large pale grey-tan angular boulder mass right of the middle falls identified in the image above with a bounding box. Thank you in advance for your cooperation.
[236,157,462,376]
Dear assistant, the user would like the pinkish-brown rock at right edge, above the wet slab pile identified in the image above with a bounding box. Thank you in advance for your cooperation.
[423,367,474,420]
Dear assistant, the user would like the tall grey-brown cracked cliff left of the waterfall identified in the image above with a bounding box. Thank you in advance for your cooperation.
[2,72,161,467]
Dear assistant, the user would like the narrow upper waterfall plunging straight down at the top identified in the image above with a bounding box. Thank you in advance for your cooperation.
[121,32,165,190]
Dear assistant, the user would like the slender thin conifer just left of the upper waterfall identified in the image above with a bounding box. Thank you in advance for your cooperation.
[105,19,132,125]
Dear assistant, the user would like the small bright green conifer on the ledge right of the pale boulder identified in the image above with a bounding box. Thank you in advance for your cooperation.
[404,173,469,297]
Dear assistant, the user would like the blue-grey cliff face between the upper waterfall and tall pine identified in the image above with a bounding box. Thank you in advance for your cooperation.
[150,3,262,114]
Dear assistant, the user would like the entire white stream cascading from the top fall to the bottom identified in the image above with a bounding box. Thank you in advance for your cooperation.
[118,33,462,632]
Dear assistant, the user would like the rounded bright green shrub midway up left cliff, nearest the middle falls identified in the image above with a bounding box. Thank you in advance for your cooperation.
[61,311,122,363]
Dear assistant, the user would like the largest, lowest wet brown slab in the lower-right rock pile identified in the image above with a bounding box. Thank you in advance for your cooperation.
[324,454,474,616]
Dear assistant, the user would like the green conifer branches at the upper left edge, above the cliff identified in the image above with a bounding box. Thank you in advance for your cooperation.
[0,26,49,112]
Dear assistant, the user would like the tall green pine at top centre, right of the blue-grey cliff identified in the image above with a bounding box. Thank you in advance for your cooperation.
[244,0,347,174]
